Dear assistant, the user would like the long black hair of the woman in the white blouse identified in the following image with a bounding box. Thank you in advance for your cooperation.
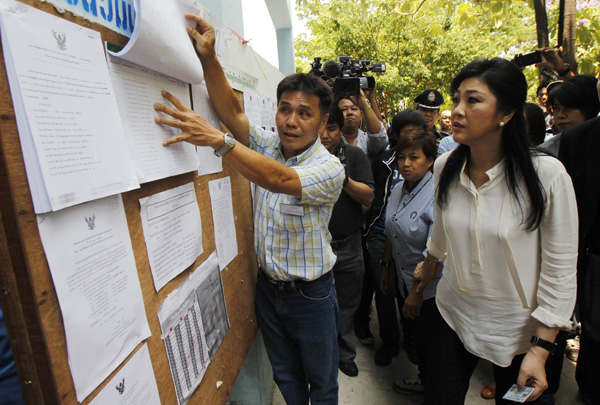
[437,58,546,230]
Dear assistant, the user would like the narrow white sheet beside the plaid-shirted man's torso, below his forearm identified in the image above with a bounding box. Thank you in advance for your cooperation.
[208,177,238,270]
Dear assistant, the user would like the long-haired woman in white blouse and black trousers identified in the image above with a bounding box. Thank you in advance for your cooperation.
[416,58,577,404]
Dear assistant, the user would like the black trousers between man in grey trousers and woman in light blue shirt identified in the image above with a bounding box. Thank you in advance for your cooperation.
[354,229,400,347]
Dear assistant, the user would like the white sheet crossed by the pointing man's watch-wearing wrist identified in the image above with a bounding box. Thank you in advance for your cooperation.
[192,82,223,176]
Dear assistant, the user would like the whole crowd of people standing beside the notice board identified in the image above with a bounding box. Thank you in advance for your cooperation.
[148,15,600,404]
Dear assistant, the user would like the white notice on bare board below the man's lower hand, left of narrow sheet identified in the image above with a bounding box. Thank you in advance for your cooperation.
[140,183,202,291]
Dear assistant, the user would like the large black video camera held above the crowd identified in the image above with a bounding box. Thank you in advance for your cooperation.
[311,56,385,97]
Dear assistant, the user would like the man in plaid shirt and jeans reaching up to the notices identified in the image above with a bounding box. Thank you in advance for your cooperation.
[155,14,345,404]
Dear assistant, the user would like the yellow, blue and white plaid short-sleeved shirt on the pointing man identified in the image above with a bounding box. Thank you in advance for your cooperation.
[250,125,345,280]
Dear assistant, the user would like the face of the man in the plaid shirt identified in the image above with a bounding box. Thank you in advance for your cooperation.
[275,90,329,159]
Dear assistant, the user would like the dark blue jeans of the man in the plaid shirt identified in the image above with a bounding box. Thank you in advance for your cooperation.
[256,270,339,405]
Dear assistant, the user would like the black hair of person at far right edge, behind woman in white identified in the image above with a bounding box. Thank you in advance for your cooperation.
[547,75,600,120]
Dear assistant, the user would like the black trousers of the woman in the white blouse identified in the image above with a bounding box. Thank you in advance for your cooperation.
[424,306,552,405]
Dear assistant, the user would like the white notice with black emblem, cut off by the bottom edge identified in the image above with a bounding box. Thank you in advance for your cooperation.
[90,343,160,405]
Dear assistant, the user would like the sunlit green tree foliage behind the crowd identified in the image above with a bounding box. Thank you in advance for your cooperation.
[295,0,600,114]
